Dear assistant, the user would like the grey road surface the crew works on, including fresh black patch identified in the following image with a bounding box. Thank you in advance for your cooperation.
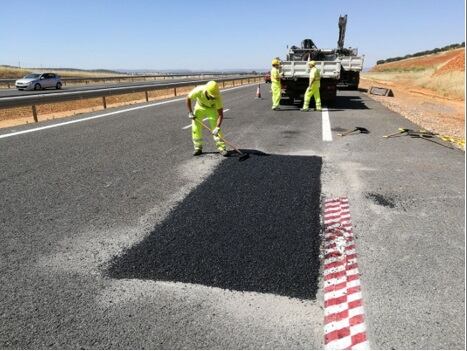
[0,85,465,349]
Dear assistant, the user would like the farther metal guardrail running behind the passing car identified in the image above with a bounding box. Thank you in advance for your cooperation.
[0,72,251,88]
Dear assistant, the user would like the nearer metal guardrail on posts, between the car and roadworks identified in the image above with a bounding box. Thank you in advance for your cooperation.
[0,75,262,122]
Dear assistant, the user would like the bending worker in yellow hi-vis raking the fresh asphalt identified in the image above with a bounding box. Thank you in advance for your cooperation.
[186,80,228,156]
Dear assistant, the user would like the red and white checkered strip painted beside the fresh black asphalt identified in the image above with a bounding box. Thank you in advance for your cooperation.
[323,197,370,350]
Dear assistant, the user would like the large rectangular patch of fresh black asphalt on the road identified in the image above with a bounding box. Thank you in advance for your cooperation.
[108,154,322,299]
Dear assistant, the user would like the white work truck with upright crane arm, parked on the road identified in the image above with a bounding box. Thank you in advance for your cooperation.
[281,15,363,104]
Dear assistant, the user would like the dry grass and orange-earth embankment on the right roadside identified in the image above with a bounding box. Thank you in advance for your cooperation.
[360,49,465,144]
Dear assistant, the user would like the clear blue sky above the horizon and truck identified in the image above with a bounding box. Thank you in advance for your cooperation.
[0,0,465,70]
